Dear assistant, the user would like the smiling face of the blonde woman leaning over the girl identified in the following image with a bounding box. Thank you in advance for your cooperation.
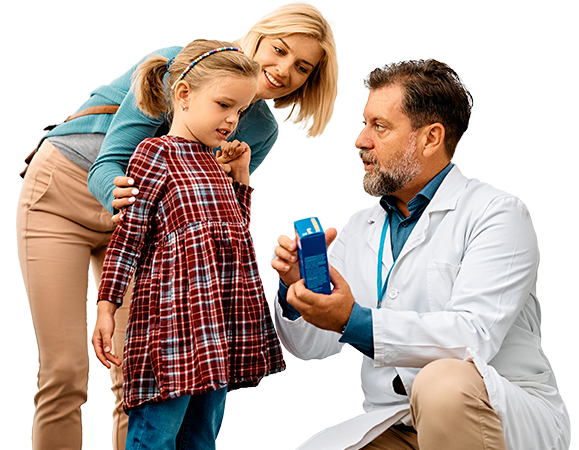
[253,34,323,100]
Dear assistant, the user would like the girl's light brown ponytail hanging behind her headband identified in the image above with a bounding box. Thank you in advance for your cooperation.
[133,56,170,119]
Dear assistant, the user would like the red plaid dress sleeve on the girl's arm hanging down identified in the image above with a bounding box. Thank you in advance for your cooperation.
[97,140,167,305]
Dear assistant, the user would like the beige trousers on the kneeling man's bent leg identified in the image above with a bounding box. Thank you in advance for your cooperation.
[364,359,506,450]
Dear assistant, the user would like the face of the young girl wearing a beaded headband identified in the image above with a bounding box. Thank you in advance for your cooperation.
[176,76,257,148]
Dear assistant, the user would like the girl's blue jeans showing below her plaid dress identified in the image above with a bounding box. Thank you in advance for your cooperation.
[125,388,227,450]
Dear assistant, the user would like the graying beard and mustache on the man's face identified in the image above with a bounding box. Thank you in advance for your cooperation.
[360,135,420,197]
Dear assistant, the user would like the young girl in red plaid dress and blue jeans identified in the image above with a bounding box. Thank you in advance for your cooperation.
[92,40,285,449]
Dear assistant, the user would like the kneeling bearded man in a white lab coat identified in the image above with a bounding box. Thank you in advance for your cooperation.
[272,59,570,450]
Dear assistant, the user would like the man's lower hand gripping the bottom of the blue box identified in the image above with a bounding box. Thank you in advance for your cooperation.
[286,264,354,333]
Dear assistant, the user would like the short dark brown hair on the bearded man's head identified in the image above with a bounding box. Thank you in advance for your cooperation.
[364,58,474,159]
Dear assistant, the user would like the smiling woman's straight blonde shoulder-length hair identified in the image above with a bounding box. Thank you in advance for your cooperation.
[237,3,338,137]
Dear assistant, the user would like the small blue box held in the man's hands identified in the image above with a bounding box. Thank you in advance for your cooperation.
[295,217,332,294]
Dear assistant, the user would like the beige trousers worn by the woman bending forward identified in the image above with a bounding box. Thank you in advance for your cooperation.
[16,141,130,450]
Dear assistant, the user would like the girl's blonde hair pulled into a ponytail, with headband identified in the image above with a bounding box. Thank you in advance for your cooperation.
[133,39,260,118]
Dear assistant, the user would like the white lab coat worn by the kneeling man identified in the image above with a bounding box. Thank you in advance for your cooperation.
[274,167,570,450]
